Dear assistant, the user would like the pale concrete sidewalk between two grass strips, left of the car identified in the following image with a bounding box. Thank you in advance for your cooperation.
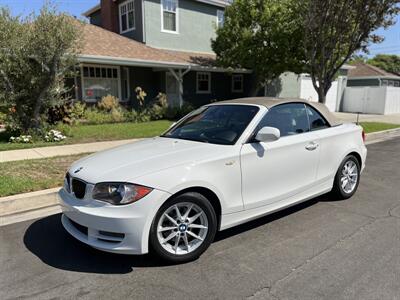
[0,139,139,163]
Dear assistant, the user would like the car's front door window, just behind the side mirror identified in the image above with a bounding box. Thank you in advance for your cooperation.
[257,103,310,137]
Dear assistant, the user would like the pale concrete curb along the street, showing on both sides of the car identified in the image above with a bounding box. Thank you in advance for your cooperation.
[0,128,400,226]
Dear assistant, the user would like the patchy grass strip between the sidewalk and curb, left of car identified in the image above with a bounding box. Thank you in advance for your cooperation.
[0,154,88,197]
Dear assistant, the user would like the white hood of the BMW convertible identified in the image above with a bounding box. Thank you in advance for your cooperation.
[69,137,218,183]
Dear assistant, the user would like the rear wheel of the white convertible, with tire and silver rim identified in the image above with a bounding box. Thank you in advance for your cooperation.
[332,155,360,200]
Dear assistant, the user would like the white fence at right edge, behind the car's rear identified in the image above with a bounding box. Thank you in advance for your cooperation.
[343,86,400,115]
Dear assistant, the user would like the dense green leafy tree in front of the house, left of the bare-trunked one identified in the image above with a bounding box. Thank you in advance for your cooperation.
[212,0,304,95]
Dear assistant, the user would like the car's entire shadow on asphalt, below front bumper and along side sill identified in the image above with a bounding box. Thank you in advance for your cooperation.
[24,195,335,274]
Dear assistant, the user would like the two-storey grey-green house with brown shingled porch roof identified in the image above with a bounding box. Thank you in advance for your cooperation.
[75,0,252,106]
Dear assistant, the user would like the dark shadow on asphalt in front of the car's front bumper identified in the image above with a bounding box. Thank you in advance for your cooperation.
[24,214,167,274]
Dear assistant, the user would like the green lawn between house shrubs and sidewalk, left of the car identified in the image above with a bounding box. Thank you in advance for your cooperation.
[0,120,172,151]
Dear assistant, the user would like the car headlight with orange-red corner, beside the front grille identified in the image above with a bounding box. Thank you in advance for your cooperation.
[92,182,153,205]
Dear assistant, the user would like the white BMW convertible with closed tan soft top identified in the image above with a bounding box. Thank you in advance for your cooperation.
[59,98,367,262]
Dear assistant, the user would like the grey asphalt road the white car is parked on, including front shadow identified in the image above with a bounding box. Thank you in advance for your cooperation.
[0,139,400,299]
